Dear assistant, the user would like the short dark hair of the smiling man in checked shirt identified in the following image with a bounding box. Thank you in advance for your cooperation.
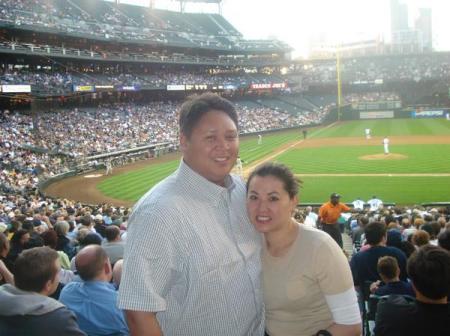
[178,93,239,138]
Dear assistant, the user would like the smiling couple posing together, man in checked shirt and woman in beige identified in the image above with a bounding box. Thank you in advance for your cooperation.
[118,93,361,336]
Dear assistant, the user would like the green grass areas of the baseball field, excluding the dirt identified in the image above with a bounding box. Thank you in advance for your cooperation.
[98,119,450,204]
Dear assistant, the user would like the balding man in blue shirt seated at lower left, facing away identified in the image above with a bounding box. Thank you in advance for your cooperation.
[59,245,129,335]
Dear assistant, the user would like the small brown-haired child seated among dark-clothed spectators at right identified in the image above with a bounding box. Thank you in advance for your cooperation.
[370,256,416,297]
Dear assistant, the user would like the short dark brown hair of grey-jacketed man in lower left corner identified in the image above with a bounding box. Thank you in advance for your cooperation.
[14,246,59,293]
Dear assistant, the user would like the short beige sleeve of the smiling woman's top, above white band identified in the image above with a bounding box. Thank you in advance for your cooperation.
[314,236,353,295]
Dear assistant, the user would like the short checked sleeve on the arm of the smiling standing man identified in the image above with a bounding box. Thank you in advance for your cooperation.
[118,207,182,312]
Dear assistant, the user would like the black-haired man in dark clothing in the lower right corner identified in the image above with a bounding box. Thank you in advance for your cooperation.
[375,245,450,336]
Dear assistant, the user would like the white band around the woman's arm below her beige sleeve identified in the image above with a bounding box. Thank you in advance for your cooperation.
[325,287,361,325]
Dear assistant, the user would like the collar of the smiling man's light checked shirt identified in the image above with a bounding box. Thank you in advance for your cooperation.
[177,159,236,204]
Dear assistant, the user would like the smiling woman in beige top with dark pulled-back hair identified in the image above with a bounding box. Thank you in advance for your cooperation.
[247,163,361,336]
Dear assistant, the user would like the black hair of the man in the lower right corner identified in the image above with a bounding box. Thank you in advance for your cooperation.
[407,245,450,300]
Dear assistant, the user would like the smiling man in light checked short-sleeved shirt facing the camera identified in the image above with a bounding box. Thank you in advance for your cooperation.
[119,93,264,336]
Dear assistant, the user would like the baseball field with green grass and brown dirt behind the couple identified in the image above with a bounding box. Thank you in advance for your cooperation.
[43,119,450,205]
